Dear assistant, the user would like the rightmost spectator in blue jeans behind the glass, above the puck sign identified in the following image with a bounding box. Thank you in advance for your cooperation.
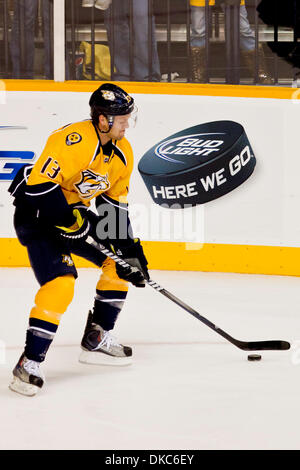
[190,0,273,85]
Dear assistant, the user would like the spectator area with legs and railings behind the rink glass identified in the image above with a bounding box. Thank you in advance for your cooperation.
[0,0,300,86]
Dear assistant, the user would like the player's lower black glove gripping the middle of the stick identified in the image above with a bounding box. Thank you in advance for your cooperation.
[112,238,150,287]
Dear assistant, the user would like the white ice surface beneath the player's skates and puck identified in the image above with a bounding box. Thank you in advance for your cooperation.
[0,268,300,450]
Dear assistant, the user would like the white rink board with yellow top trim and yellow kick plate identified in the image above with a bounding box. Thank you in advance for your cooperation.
[0,80,300,275]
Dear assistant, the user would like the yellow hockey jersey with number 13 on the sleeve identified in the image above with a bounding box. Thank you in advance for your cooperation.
[27,120,133,206]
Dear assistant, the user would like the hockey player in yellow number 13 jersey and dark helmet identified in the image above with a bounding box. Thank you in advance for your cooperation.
[9,83,149,395]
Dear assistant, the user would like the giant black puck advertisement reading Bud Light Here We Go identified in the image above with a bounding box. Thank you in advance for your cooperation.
[138,121,256,208]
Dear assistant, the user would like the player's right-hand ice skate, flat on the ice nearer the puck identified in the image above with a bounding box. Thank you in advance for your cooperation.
[79,312,132,366]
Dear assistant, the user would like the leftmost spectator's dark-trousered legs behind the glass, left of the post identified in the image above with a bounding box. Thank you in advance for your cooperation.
[10,0,53,79]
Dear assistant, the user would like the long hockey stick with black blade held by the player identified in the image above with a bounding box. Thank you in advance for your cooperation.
[86,237,291,351]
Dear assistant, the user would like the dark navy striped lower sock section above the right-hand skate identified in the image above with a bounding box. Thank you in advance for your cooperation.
[93,289,127,331]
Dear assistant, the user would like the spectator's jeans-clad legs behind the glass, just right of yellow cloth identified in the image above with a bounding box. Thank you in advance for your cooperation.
[103,0,161,81]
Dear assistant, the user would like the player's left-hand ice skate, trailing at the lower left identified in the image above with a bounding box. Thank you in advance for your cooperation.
[9,353,45,397]
